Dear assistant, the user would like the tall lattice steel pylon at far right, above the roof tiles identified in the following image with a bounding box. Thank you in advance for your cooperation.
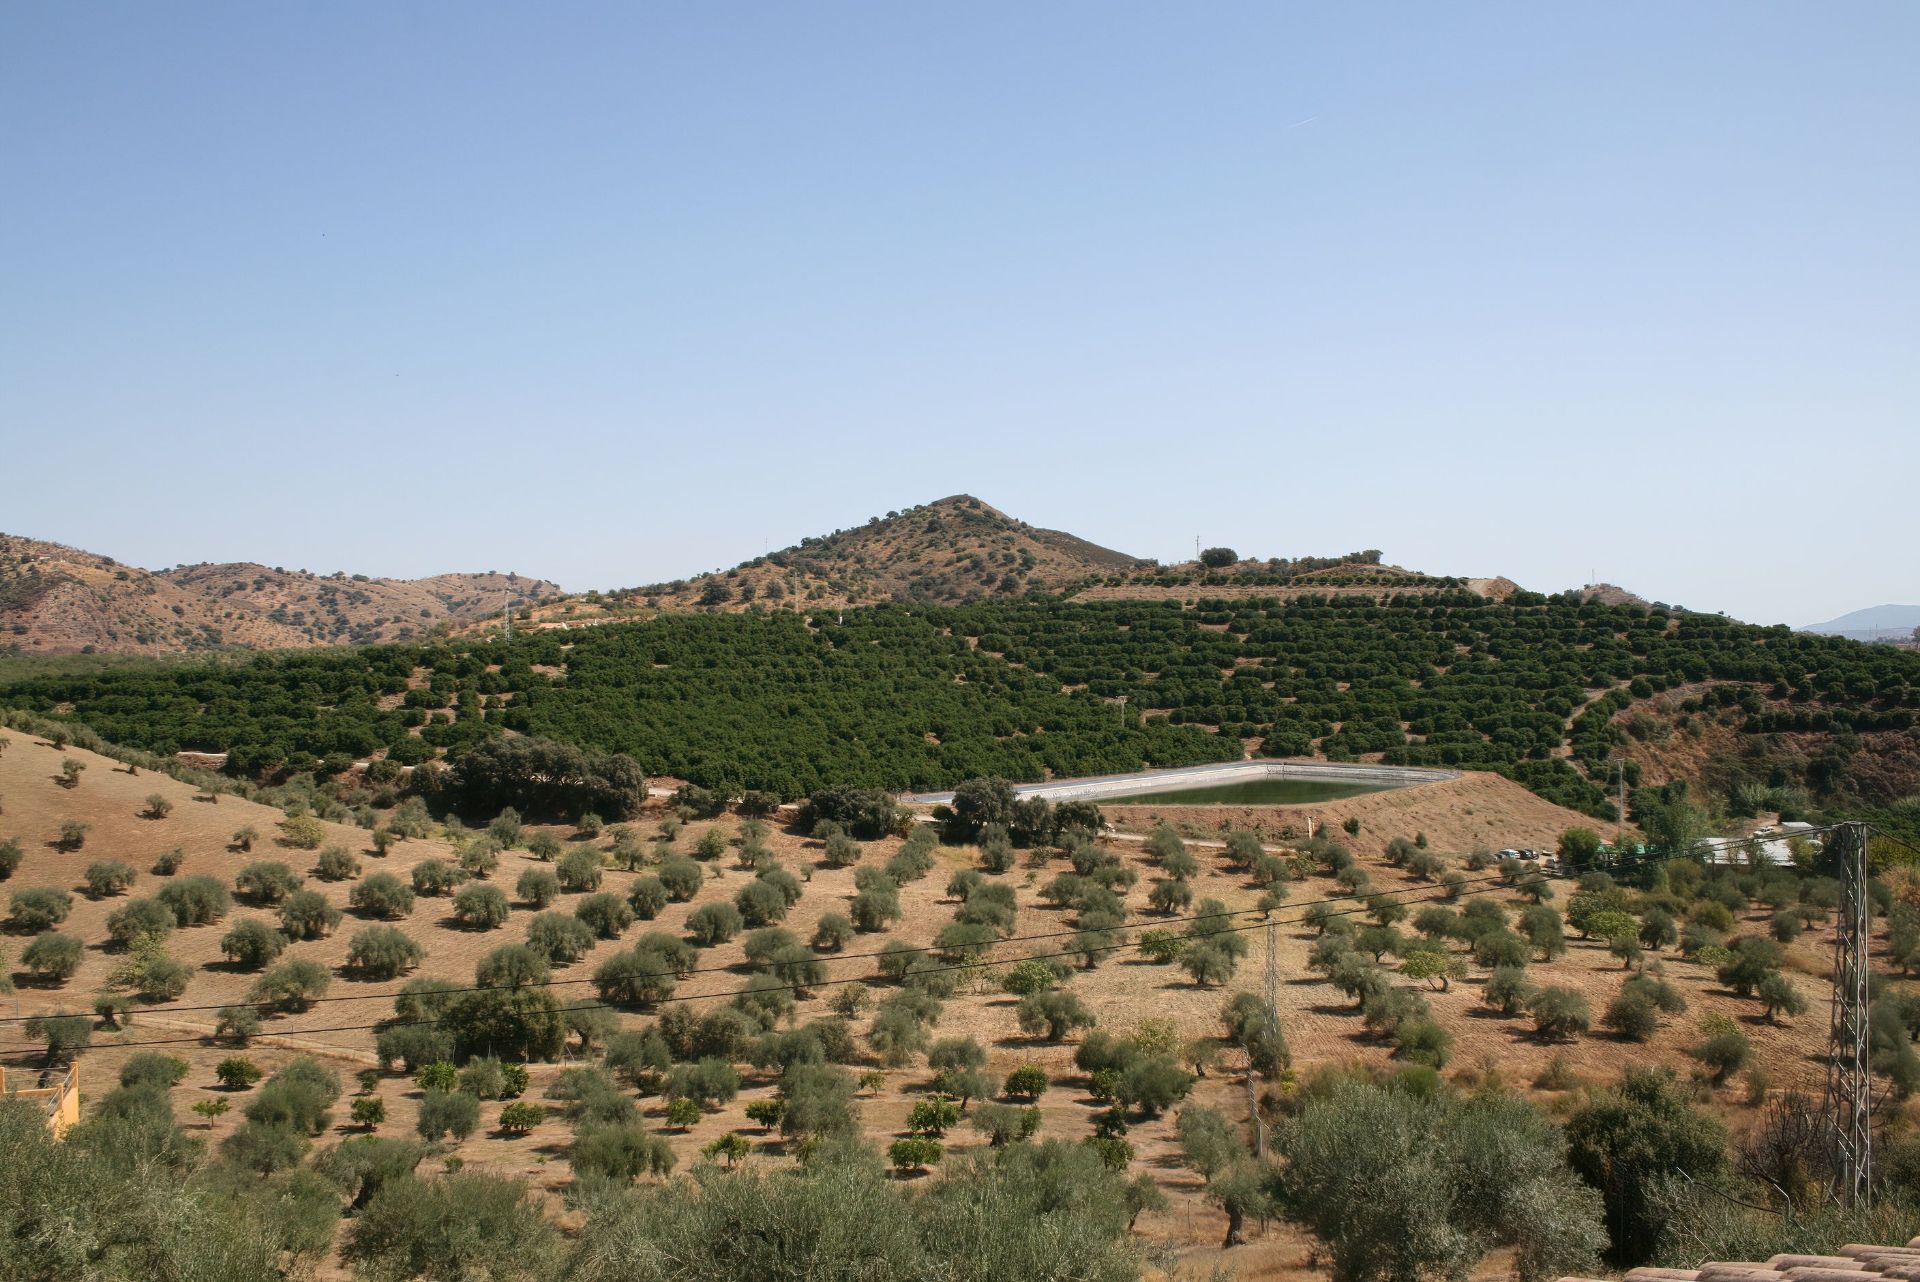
[1826,823,1874,1205]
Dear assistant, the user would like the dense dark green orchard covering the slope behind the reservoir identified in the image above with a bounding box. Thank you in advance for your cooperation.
[0,591,1920,816]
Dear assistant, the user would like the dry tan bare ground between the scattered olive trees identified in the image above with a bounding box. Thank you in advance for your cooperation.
[0,731,1830,1278]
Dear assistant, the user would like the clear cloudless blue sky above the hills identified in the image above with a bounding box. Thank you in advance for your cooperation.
[0,0,1920,624]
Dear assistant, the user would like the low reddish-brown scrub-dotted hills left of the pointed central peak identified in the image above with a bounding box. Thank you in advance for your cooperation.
[0,534,559,654]
